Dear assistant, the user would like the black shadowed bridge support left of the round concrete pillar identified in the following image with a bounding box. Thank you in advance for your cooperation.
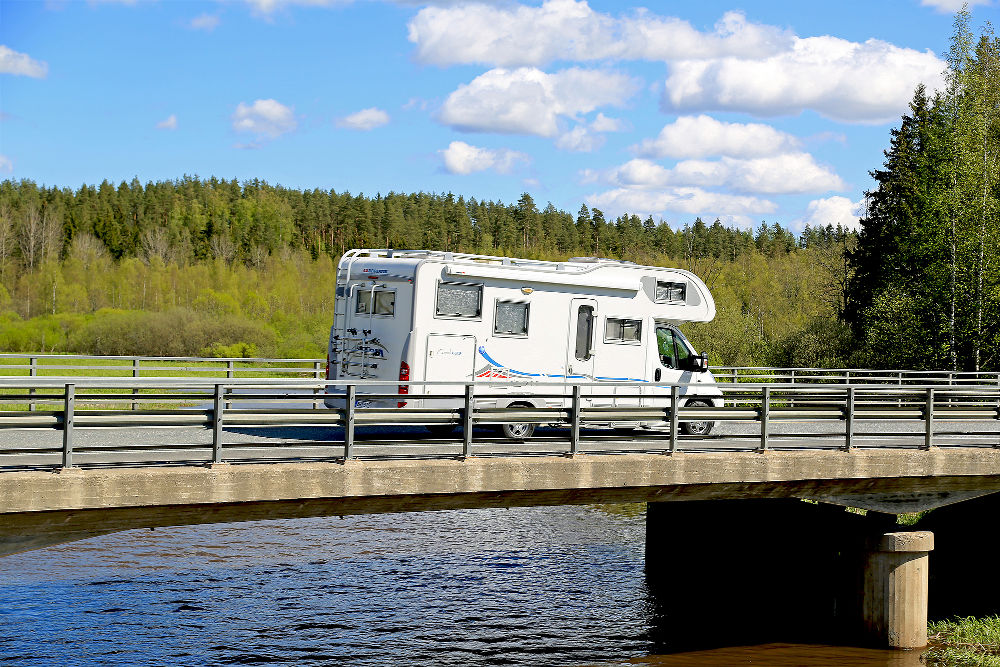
[646,499,896,650]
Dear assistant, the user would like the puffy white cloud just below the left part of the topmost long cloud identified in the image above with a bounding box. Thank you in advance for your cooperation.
[438,67,638,137]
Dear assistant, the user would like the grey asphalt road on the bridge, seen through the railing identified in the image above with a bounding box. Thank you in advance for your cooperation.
[0,410,1000,474]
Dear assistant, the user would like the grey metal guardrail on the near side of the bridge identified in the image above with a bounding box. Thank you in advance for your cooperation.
[0,377,1000,468]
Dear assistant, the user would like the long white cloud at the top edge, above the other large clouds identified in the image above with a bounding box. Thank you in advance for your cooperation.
[409,0,791,67]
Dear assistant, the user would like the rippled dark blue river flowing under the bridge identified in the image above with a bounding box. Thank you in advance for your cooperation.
[0,507,921,667]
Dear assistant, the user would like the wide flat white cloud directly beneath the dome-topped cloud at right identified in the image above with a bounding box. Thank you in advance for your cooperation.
[586,153,844,194]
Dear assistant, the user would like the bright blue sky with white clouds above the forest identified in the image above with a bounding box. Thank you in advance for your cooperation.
[0,0,1000,229]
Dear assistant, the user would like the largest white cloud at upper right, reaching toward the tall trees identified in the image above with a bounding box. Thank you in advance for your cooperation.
[662,36,945,122]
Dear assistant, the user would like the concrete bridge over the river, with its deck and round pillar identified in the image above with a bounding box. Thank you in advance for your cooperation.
[0,376,1000,647]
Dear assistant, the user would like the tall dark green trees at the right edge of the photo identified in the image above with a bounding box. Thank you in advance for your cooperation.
[844,19,1000,370]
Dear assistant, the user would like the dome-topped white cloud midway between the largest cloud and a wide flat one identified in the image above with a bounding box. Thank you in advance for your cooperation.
[633,115,799,158]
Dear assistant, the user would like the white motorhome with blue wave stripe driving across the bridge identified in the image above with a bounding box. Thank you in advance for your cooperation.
[327,250,721,438]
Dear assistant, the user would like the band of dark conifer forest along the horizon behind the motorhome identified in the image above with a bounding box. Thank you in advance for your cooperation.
[0,176,843,278]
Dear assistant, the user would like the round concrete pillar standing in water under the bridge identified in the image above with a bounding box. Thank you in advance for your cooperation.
[863,531,934,649]
